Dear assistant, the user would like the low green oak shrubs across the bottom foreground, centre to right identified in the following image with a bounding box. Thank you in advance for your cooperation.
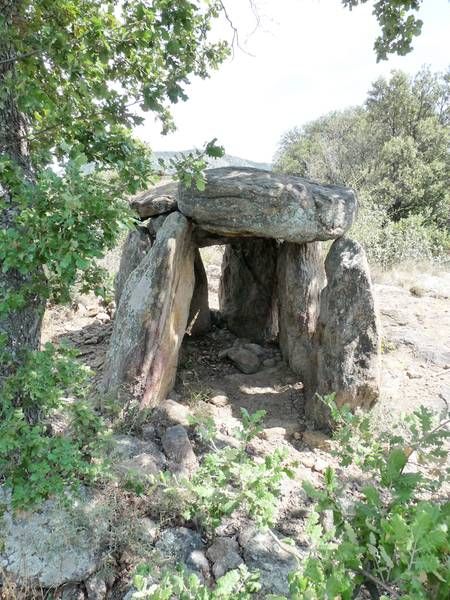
[132,396,450,600]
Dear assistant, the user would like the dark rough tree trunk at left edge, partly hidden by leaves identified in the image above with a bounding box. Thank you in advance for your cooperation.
[0,0,44,386]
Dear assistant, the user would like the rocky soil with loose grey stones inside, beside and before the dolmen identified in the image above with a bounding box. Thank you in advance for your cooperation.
[4,255,450,600]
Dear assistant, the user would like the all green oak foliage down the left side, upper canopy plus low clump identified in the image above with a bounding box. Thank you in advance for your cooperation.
[0,0,228,506]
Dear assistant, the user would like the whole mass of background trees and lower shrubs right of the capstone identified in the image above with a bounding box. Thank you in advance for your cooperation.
[276,69,450,268]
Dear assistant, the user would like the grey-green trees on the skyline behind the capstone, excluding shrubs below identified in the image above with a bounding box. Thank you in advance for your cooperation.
[276,68,450,225]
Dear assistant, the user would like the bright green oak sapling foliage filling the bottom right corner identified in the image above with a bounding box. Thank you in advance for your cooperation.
[291,397,450,600]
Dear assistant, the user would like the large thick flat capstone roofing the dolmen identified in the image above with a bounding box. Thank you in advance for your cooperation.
[178,167,357,243]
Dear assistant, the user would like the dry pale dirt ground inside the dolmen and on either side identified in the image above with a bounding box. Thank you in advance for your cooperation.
[43,246,450,452]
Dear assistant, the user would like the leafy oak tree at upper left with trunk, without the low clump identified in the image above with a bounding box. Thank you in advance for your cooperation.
[0,0,228,377]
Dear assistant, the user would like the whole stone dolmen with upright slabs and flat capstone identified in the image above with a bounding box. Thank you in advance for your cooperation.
[102,167,380,427]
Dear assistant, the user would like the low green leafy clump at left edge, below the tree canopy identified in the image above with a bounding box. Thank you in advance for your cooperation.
[0,344,108,508]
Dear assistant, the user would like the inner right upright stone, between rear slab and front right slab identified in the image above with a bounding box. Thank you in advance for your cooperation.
[278,242,325,396]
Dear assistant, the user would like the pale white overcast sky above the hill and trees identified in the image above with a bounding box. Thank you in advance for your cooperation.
[136,0,450,162]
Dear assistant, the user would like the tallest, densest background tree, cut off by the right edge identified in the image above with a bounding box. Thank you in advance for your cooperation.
[366,69,450,224]
